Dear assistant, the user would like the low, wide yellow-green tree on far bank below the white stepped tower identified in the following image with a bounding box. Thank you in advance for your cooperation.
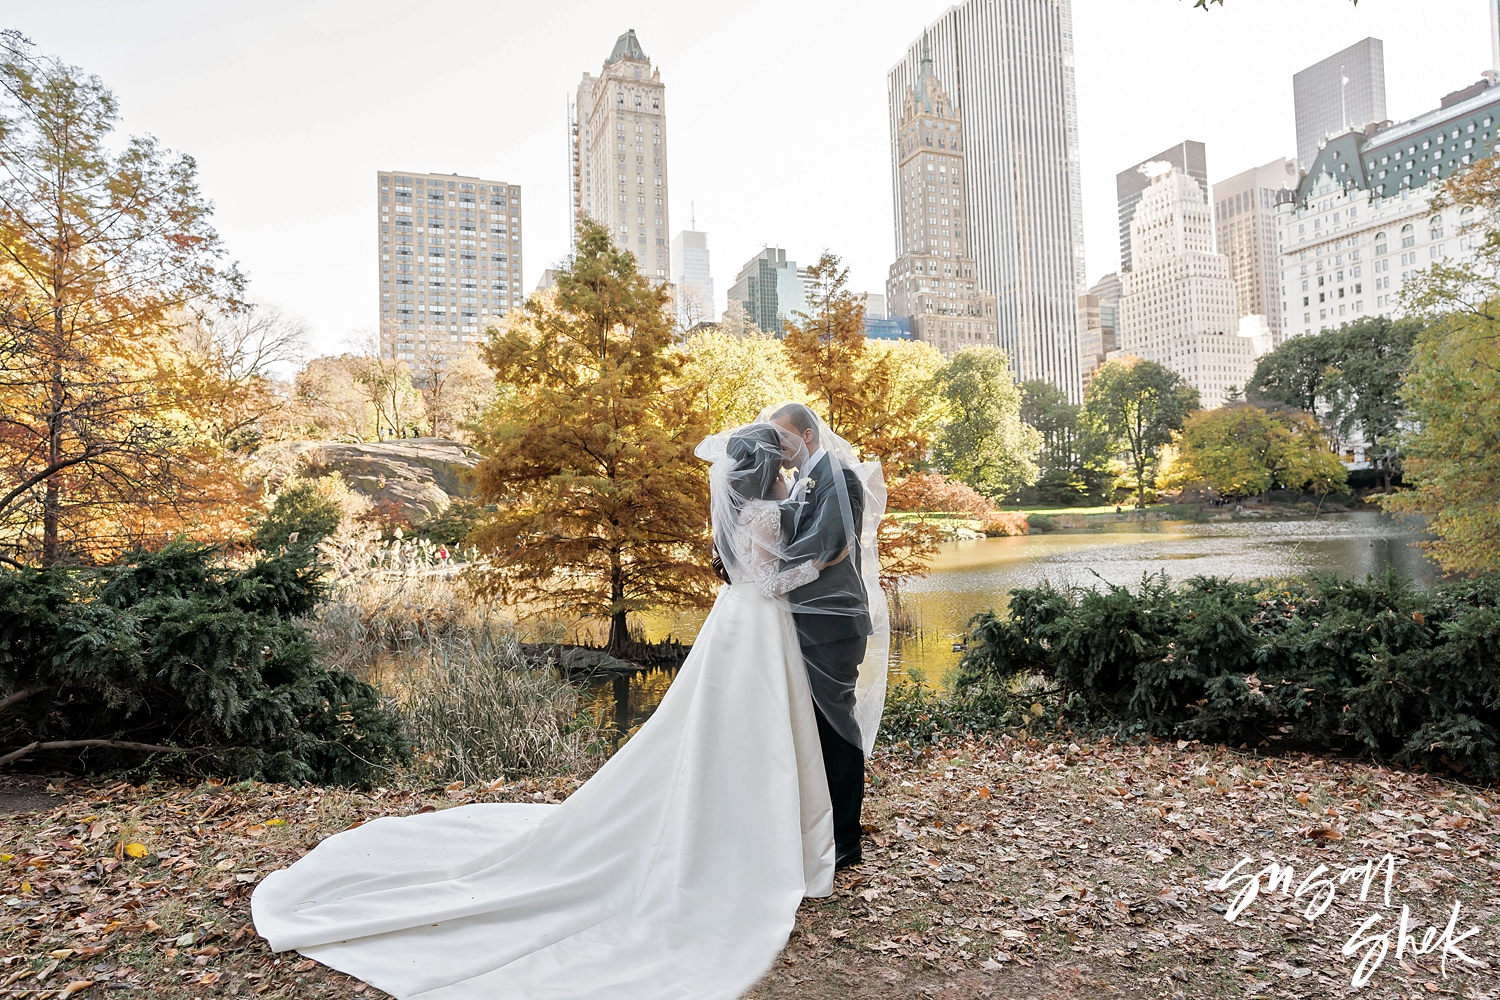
[1173,403,1346,496]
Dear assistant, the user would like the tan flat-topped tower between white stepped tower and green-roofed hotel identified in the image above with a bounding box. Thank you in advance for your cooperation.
[1214,159,1301,349]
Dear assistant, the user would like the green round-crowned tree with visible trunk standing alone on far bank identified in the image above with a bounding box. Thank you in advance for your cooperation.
[1080,360,1199,507]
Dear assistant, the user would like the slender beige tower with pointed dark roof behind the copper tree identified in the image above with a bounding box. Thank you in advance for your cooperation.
[569,28,672,282]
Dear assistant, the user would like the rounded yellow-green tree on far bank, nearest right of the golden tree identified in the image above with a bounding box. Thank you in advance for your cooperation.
[933,348,1043,498]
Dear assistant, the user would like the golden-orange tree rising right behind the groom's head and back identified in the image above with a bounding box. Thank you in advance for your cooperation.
[782,252,944,586]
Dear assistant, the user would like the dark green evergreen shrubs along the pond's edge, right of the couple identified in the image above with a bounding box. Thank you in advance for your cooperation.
[956,573,1500,781]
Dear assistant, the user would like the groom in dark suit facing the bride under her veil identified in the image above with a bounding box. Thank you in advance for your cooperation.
[771,403,872,868]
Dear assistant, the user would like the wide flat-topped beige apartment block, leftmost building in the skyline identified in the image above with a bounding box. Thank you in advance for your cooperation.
[375,171,522,367]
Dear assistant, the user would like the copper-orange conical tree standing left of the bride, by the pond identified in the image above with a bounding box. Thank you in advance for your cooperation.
[476,220,716,651]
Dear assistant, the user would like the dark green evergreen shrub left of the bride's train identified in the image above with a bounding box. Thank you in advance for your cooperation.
[0,541,410,784]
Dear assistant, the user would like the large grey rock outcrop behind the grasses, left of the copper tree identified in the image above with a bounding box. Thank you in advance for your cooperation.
[260,438,480,525]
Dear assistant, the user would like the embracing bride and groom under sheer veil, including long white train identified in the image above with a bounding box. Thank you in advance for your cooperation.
[252,403,890,1000]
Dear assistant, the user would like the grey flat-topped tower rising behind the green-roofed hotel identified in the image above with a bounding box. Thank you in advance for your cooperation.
[1292,37,1386,169]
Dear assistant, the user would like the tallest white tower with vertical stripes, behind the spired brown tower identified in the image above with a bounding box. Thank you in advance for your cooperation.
[887,0,1085,400]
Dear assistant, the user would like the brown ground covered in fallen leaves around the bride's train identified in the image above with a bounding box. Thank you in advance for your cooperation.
[0,738,1500,1000]
